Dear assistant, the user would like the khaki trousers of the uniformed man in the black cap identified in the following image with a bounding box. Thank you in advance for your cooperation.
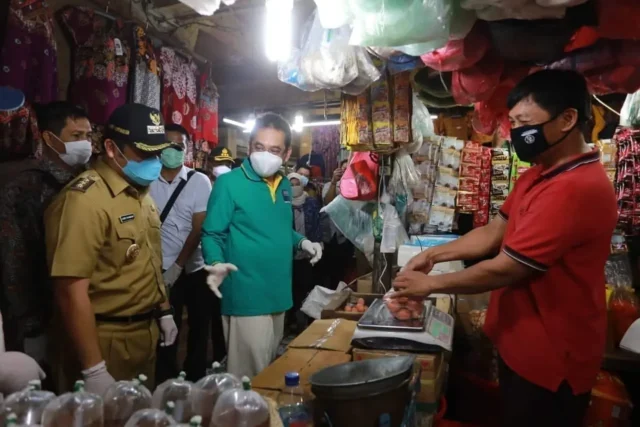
[52,319,160,394]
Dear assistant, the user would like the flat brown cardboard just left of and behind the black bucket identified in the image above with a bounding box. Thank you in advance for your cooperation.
[251,348,351,396]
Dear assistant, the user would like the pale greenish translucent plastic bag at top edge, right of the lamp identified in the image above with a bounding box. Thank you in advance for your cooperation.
[349,0,451,46]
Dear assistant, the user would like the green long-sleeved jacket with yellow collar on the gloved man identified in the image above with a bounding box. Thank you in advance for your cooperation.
[202,160,304,316]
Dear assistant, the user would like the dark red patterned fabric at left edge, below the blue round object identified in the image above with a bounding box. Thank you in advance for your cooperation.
[0,104,42,162]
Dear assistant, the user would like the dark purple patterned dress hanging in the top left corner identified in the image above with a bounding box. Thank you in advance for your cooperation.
[0,0,58,103]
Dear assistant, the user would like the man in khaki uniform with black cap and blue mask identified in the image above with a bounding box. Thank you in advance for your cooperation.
[45,104,178,394]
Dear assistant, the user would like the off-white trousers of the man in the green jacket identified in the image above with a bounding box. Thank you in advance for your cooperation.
[222,313,284,378]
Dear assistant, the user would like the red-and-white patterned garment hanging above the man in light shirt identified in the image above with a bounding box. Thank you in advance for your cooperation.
[160,47,198,135]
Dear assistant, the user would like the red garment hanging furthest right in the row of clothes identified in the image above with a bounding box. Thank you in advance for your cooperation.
[195,72,219,152]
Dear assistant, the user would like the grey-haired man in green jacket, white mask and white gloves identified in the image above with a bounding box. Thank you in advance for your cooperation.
[202,113,322,377]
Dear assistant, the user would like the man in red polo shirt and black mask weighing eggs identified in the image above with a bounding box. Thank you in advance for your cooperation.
[394,70,617,427]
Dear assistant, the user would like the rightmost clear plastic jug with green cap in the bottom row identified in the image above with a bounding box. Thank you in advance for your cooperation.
[209,377,271,427]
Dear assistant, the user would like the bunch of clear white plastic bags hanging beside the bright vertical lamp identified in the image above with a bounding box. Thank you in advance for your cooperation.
[278,12,380,95]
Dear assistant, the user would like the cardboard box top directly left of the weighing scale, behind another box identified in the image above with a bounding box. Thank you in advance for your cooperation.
[288,319,357,353]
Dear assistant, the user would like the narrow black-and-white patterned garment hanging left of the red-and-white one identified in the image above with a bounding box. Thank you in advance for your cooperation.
[131,25,161,110]
